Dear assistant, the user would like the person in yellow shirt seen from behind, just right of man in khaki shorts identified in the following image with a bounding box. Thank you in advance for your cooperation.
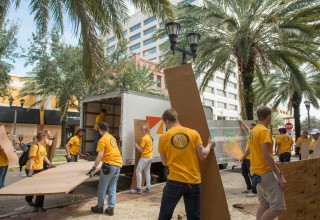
[276,128,293,162]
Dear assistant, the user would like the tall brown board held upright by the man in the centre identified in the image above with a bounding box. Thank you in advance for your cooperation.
[164,64,230,220]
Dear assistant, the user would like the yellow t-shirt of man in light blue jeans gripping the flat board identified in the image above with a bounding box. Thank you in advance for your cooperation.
[97,133,122,167]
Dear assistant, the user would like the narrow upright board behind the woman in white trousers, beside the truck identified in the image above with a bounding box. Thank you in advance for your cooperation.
[131,119,148,189]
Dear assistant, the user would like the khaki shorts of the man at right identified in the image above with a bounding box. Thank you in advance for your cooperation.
[257,172,286,210]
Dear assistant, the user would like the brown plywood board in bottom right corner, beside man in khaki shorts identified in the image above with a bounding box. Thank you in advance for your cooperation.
[278,159,320,220]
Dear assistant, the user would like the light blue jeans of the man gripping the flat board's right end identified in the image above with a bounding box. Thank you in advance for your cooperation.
[98,165,120,208]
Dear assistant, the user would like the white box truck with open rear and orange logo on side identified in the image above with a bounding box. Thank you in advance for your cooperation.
[80,91,248,179]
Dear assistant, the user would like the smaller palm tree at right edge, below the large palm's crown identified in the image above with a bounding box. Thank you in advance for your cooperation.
[254,66,320,139]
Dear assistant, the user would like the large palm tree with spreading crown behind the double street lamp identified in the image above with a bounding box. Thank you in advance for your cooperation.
[159,0,320,120]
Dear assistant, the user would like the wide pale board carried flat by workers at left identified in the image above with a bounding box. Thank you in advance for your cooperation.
[0,162,100,196]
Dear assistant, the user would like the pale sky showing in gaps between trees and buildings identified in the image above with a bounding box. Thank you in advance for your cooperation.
[7,1,320,120]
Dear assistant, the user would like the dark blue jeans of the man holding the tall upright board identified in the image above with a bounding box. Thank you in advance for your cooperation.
[158,180,200,220]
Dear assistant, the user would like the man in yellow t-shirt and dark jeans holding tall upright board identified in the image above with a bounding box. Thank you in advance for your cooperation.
[158,109,215,220]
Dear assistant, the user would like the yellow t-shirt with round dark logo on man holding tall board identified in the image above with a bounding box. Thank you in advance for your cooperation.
[158,126,202,184]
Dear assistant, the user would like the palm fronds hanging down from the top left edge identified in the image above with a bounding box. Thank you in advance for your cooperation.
[0,0,174,84]
